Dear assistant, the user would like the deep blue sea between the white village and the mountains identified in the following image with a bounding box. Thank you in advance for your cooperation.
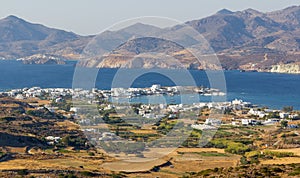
[0,60,300,109]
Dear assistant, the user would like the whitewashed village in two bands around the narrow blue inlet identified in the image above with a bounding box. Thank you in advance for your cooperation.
[0,85,300,127]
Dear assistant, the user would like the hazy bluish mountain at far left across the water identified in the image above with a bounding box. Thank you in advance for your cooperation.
[0,16,91,59]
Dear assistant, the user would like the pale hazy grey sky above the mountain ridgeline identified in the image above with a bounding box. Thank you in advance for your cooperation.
[0,0,300,35]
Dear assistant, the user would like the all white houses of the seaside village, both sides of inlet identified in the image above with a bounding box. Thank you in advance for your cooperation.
[2,85,299,131]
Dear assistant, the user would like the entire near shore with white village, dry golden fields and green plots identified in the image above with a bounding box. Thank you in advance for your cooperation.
[0,85,300,177]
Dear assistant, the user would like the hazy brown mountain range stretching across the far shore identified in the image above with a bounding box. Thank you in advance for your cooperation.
[0,6,300,71]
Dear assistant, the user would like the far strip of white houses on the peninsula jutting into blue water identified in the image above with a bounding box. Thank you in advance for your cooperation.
[0,84,225,99]
